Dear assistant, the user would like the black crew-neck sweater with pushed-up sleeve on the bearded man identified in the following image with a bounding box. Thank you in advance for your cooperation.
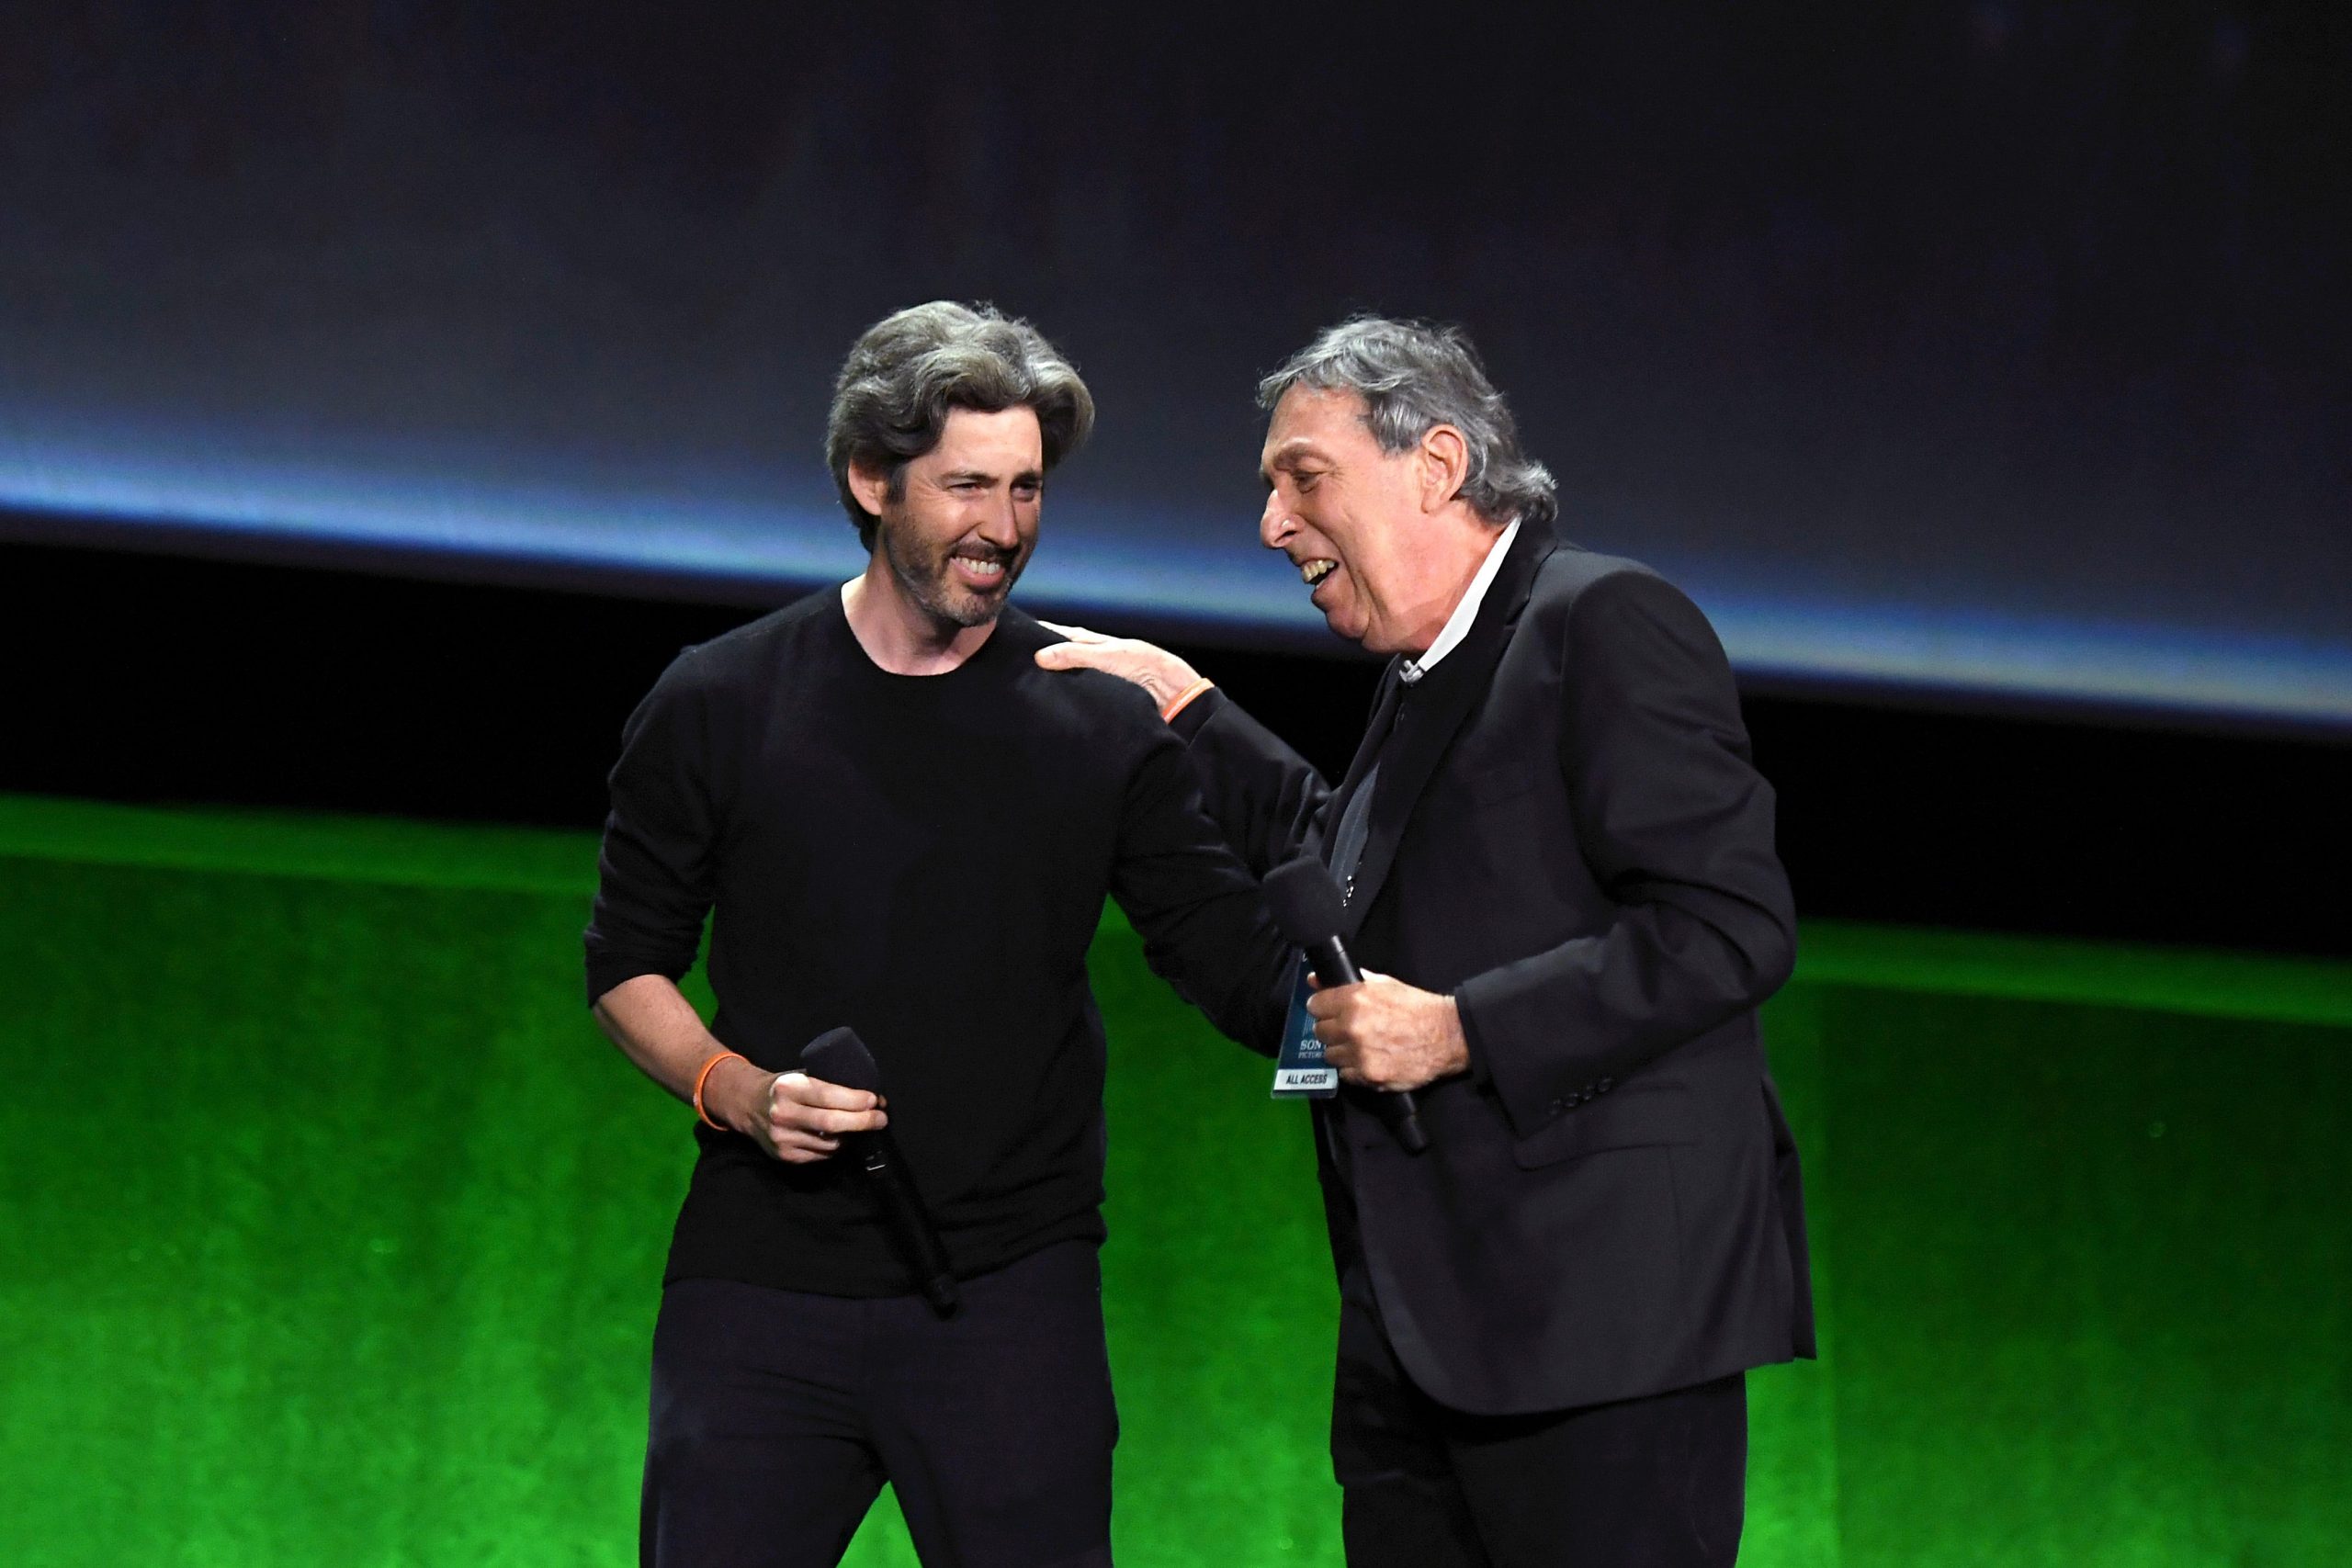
[585,592,1289,1295]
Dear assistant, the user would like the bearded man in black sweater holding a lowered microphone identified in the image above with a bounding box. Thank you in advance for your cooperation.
[585,303,1289,1568]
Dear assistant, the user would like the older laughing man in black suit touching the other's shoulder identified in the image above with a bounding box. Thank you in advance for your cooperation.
[1037,317,1814,1568]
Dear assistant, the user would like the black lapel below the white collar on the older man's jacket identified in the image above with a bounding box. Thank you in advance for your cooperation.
[1331,525,1557,924]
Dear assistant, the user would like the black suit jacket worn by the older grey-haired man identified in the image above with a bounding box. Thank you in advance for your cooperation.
[1176,525,1814,1416]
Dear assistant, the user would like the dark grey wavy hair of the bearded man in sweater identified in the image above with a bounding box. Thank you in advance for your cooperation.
[826,299,1093,550]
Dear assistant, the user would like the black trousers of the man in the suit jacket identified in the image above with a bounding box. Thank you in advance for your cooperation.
[1331,1269,1747,1568]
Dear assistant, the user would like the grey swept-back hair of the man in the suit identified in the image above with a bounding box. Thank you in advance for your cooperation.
[1259,315,1559,522]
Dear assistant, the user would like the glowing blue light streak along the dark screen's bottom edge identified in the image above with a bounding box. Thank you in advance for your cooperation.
[0,442,2352,731]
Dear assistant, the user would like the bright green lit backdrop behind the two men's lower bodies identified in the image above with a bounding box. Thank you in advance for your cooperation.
[0,799,2352,1568]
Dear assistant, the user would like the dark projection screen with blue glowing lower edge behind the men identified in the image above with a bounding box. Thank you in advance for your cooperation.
[0,0,2352,727]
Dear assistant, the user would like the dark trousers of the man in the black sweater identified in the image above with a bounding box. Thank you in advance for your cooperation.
[638,1241,1120,1568]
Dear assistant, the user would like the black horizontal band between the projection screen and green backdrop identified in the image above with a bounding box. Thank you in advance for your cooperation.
[0,546,2352,954]
